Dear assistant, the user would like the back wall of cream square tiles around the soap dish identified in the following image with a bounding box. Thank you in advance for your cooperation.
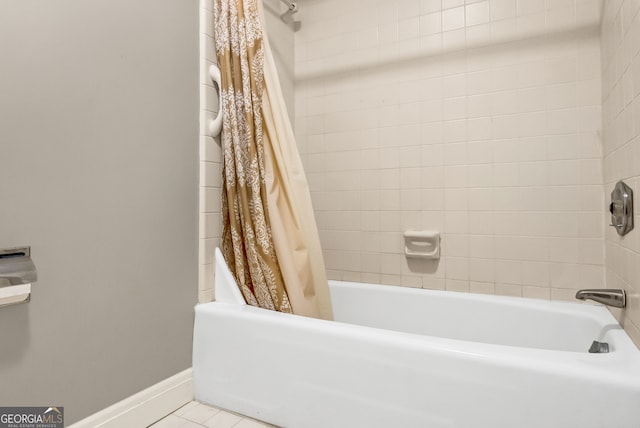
[295,0,604,299]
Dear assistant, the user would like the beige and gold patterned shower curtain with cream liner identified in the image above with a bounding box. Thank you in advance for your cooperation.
[214,0,332,319]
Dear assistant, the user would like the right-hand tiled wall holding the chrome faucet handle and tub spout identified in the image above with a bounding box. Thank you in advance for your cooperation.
[601,0,640,346]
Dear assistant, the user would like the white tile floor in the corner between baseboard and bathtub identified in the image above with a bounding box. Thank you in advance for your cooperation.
[149,401,275,428]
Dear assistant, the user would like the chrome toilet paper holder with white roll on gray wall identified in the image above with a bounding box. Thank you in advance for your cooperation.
[0,247,38,306]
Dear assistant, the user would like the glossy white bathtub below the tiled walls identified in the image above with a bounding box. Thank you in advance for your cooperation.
[193,251,640,428]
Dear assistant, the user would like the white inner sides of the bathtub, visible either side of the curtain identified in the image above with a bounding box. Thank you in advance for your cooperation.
[215,249,624,353]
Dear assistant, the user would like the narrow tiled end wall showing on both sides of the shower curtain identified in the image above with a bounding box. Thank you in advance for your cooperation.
[198,0,295,302]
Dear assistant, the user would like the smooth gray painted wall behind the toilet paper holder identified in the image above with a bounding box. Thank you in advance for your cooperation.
[0,0,198,423]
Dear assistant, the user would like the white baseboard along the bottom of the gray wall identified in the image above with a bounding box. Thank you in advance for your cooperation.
[69,368,193,428]
